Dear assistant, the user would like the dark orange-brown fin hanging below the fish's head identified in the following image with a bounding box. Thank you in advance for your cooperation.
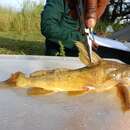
[117,84,130,111]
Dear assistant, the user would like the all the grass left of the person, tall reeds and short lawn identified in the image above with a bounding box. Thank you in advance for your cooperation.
[0,0,45,55]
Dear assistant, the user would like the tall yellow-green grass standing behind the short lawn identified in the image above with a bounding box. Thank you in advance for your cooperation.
[0,0,43,33]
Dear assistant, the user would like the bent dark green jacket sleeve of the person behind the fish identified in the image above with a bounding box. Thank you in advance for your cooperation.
[41,0,83,47]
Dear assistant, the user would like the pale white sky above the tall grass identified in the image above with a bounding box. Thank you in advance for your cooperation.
[0,0,45,9]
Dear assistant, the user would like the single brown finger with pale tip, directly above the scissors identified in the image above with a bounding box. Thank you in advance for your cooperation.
[85,0,97,28]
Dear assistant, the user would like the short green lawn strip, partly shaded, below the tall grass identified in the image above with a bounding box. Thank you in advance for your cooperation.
[0,32,44,55]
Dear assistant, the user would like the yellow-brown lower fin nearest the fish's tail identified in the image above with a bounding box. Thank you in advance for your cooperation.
[27,87,54,96]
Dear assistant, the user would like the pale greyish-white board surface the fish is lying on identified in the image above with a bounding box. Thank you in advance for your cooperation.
[0,56,130,130]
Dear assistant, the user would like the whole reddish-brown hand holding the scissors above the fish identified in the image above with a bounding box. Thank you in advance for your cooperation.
[85,0,108,28]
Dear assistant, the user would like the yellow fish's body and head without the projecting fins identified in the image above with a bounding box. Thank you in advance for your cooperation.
[6,60,130,92]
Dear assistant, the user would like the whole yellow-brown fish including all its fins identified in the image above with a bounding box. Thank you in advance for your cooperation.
[0,41,130,110]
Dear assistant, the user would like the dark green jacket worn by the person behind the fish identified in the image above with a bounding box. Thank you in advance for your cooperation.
[41,0,83,48]
